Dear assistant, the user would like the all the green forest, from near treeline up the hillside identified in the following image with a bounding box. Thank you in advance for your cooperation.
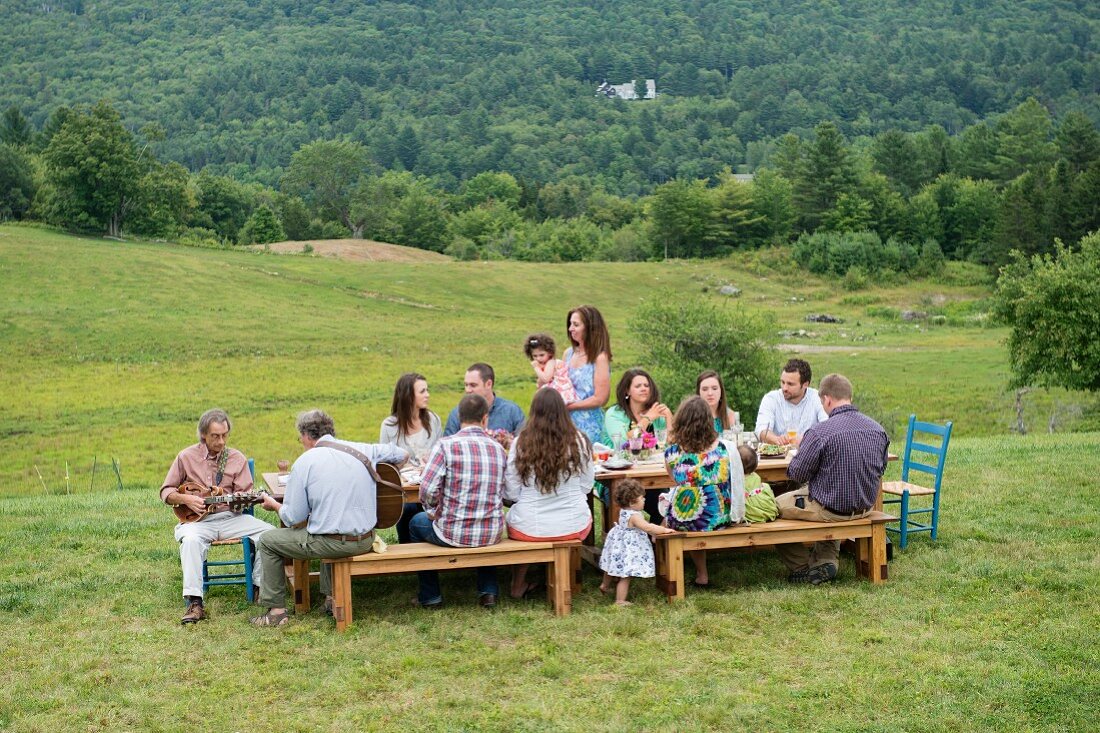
[0,0,1100,272]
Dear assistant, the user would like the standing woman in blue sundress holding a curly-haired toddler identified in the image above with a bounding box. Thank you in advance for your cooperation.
[562,306,612,442]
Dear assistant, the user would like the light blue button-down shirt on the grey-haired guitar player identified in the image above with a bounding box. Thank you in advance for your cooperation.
[278,435,408,535]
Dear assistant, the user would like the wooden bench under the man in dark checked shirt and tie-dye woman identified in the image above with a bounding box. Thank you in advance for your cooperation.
[656,512,895,603]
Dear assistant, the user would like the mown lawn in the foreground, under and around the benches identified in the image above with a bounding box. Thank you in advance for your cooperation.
[0,434,1100,732]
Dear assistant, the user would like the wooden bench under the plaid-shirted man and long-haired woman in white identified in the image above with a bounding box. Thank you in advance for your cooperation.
[323,539,581,631]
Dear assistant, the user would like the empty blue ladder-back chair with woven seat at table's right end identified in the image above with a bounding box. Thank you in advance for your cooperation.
[882,415,952,549]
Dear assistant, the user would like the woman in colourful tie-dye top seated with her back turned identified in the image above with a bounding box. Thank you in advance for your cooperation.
[664,395,745,588]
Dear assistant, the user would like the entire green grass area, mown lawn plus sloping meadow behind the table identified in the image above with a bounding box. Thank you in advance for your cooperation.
[0,226,1100,732]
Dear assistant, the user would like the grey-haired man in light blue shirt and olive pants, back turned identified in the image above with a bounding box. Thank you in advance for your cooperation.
[252,409,408,626]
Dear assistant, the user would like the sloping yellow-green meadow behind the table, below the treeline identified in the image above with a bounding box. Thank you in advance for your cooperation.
[0,226,1100,496]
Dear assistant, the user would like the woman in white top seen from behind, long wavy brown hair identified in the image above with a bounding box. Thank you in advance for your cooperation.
[504,390,595,598]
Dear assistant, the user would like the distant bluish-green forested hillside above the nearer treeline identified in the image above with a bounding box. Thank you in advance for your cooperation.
[0,0,1100,194]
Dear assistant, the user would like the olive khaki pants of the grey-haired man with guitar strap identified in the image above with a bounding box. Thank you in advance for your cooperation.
[256,528,374,609]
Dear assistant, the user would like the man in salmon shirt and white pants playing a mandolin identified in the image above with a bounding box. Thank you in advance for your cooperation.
[161,408,272,624]
